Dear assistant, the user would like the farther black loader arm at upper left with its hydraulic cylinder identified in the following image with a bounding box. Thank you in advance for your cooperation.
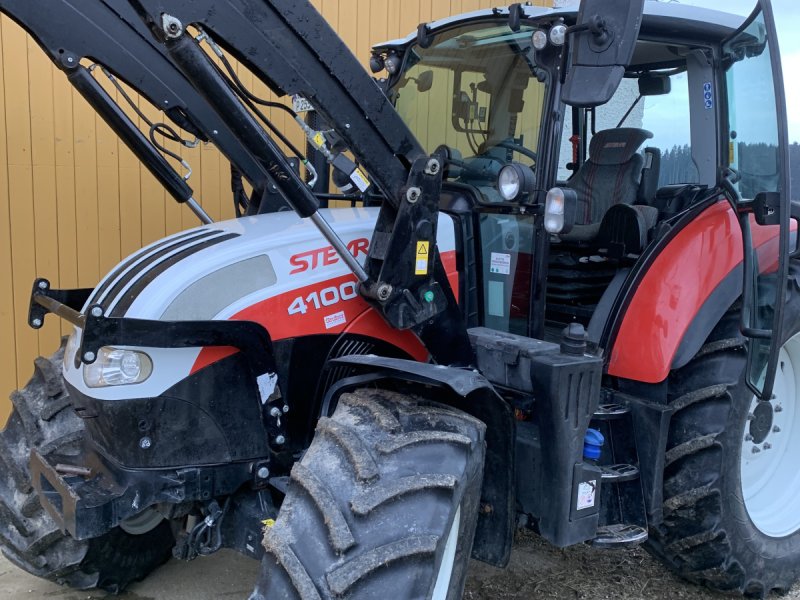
[0,0,294,220]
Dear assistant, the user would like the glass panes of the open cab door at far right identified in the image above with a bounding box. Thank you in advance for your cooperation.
[724,12,782,390]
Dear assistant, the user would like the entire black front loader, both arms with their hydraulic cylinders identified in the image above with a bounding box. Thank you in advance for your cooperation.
[0,0,474,365]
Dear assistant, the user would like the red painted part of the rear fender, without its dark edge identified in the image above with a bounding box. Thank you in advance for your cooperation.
[608,200,778,383]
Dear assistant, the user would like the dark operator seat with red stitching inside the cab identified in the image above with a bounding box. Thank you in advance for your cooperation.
[559,127,660,242]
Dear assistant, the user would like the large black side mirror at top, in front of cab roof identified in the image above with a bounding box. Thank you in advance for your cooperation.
[561,0,644,108]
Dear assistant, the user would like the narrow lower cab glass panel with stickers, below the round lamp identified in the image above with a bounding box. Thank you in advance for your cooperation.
[480,214,533,335]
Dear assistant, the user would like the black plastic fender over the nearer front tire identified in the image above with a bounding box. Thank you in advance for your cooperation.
[322,355,516,567]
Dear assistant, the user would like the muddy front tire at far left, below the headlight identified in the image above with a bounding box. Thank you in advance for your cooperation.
[0,344,174,592]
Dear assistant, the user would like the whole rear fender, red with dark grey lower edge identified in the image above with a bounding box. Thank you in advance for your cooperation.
[607,200,778,383]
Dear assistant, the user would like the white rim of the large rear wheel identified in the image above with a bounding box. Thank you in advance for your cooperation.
[741,334,800,538]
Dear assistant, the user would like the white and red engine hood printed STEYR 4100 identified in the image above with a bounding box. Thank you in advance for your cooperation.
[64,208,458,400]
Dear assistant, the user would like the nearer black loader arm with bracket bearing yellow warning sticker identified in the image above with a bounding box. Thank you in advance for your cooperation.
[130,0,473,365]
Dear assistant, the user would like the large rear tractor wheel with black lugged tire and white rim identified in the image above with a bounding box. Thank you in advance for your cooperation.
[649,292,800,597]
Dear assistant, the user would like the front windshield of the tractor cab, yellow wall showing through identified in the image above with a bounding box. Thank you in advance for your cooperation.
[390,23,547,202]
